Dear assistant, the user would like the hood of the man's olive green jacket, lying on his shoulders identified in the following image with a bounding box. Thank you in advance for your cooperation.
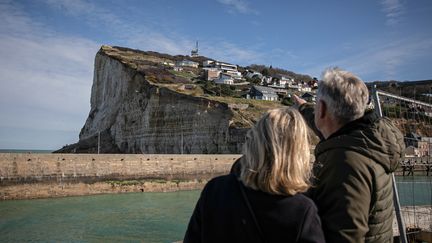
[315,111,405,173]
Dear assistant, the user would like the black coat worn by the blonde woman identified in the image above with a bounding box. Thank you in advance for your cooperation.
[184,174,324,243]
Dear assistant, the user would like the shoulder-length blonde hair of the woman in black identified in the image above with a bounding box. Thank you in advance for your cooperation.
[240,108,311,195]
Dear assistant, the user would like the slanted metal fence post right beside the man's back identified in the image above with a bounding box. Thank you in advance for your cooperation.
[372,85,408,243]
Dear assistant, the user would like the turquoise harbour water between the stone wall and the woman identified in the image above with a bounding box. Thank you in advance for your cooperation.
[0,191,200,242]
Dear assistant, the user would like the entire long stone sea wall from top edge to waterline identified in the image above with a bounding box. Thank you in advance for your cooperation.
[0,153,240,200]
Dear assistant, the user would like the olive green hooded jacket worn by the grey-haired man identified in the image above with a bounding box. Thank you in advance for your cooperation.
[299,105,405,243]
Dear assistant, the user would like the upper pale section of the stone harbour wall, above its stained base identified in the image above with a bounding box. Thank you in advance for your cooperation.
[0,153,240,185]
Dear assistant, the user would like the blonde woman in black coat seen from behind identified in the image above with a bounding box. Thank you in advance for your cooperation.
[184,108,324,243]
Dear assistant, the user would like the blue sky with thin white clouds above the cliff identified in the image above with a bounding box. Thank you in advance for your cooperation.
[0,0,432,150]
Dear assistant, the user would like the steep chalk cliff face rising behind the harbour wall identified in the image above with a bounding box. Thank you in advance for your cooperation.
[59,47,247,154]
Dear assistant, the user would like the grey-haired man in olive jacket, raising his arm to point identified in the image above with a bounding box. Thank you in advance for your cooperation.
[295,68,405,243]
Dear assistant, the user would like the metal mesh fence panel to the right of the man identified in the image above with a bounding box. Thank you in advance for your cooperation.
[372,86,432,243]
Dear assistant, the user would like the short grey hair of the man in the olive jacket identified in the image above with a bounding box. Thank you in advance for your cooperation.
[317,67,369,124]
